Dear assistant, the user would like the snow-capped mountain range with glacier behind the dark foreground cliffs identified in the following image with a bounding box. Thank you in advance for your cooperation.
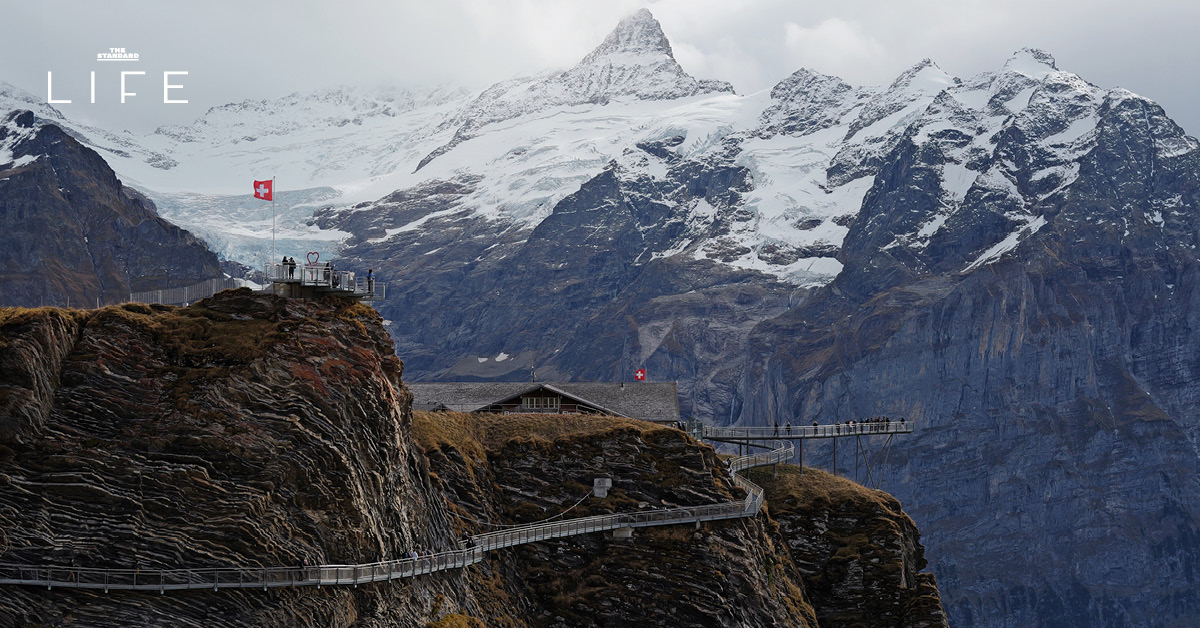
[0,10,1200,627]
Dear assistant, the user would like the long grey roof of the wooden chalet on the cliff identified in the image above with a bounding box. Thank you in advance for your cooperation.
[407,382,679,421]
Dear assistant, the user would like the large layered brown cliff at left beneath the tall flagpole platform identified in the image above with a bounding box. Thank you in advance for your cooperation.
[0,288,469,627]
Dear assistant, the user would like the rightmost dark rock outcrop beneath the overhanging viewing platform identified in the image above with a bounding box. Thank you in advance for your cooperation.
[750,466,949,628]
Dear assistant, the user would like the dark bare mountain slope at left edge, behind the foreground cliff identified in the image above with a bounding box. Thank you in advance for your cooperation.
[0,110,221,306]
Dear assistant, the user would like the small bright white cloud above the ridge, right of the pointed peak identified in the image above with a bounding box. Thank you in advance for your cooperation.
[784,18,887,82]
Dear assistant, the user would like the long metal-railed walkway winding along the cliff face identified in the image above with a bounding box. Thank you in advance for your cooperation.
[0,443,794,593]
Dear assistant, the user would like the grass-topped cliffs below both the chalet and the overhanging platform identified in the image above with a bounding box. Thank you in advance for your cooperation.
[415,413,948,628]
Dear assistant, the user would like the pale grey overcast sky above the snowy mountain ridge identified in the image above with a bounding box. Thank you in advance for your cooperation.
[0,0,1200,134]
